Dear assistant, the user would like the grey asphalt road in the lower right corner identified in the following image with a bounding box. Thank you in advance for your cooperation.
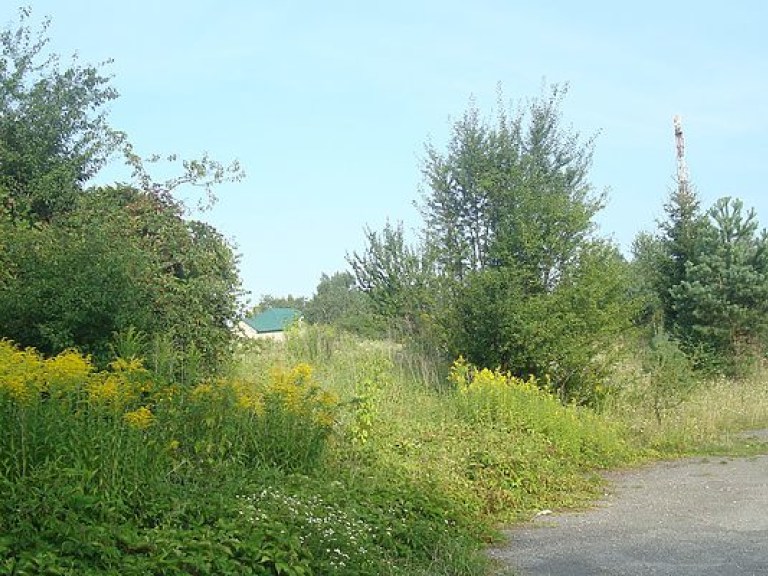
[491,436,768,576]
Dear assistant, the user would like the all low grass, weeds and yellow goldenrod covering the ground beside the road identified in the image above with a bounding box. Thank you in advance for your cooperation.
[0,327,768,575]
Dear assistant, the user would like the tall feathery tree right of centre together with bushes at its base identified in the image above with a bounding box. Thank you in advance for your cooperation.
[416,86,634,401]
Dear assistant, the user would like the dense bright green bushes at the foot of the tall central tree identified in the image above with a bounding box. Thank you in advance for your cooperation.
[449,242,636,402]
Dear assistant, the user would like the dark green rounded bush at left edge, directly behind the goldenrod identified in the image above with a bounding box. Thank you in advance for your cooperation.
[0,212,152,355]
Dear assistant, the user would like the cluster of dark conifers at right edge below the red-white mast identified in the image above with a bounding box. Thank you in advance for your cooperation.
[633,186,768,374]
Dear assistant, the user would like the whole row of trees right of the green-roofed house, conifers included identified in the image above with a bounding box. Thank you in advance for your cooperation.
[348,86,768,392]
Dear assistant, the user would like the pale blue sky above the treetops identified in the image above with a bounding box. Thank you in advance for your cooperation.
[18,0,768,300]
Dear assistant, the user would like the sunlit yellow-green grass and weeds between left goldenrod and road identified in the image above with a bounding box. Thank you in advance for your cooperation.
[240,327,635,527]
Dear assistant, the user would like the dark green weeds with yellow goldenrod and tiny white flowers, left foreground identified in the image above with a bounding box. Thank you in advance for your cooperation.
[0,341,492,575]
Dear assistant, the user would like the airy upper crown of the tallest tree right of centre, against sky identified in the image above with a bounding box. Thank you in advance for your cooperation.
[421,86,603,291]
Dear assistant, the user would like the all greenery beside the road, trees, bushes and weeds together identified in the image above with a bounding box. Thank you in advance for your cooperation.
[0,10,768,576]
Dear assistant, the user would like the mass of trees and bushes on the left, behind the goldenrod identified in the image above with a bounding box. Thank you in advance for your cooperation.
[0,10,240,370]
